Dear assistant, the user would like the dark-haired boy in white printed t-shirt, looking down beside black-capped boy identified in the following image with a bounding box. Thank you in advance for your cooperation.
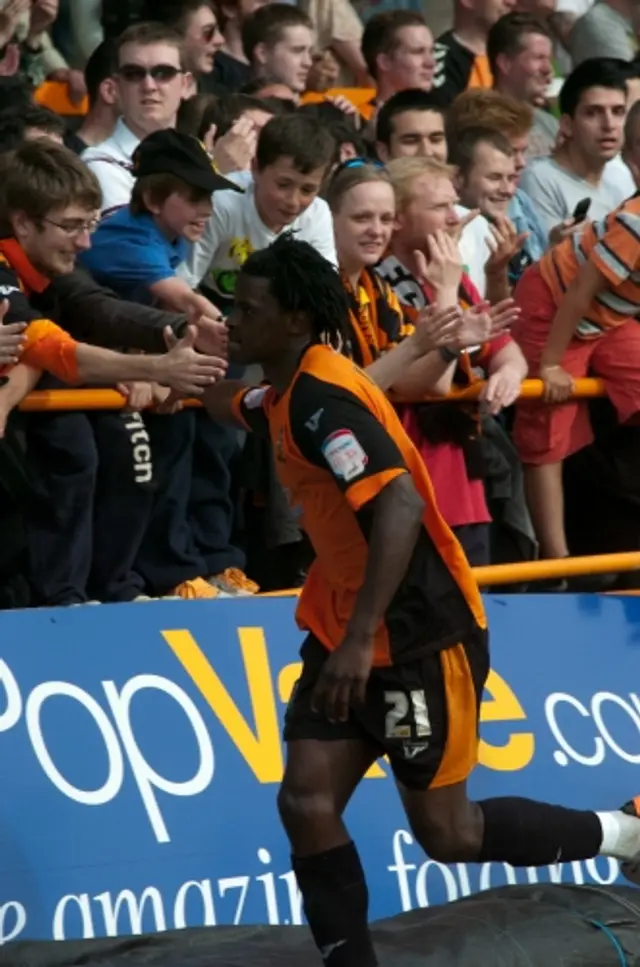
[179,114,337,310]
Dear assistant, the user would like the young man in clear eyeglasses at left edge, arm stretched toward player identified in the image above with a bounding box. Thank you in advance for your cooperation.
[0,141,225,434]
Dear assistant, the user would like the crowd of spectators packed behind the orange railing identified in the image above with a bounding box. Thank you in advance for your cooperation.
[0,0,640,608]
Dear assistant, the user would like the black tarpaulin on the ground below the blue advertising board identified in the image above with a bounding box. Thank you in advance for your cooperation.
[0,886,640,967]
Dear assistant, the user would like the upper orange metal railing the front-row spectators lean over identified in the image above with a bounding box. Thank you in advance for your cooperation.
[20,379,606,413]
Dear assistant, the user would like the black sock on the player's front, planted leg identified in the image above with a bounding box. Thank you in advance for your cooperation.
[292,843,378,967]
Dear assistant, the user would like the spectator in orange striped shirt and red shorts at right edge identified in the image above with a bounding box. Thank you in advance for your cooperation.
[513,195,640,558]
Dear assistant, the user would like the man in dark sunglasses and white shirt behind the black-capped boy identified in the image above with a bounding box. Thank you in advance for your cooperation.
[82,23,192,216]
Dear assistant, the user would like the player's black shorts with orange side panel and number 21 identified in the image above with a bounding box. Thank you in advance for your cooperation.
[284,630,489,789]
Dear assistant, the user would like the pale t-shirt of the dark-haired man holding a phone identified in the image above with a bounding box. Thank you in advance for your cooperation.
[520,158,636,239]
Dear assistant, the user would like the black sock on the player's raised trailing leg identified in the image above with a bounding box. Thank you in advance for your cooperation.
[478,798,602,866]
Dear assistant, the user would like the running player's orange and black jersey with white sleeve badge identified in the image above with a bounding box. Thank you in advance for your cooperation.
[234,346,486,666]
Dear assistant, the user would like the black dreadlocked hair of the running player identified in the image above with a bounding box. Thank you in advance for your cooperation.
[242,232,351,355]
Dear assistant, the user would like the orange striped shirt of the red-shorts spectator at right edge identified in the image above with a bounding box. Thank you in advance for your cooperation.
[539,192,640,339]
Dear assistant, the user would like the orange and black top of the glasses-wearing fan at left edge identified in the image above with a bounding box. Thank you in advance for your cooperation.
[0,238,78,383]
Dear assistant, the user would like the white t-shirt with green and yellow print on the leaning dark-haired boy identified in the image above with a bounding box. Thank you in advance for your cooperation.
[178,171,338,301]
